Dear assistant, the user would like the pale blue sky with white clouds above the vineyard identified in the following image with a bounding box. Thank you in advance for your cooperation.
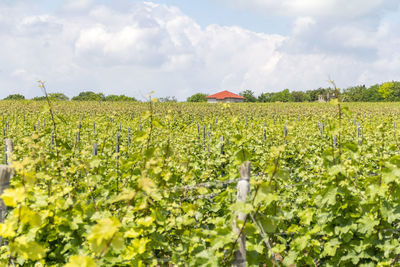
[0,0,400,101]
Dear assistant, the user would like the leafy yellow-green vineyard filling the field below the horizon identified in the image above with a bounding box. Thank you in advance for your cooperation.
[0,101,400,267]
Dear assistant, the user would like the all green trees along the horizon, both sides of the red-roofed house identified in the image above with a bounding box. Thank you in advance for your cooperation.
[4,81,400,102]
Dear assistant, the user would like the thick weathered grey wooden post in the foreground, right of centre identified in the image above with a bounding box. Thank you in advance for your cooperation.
[233,161,251,267]
